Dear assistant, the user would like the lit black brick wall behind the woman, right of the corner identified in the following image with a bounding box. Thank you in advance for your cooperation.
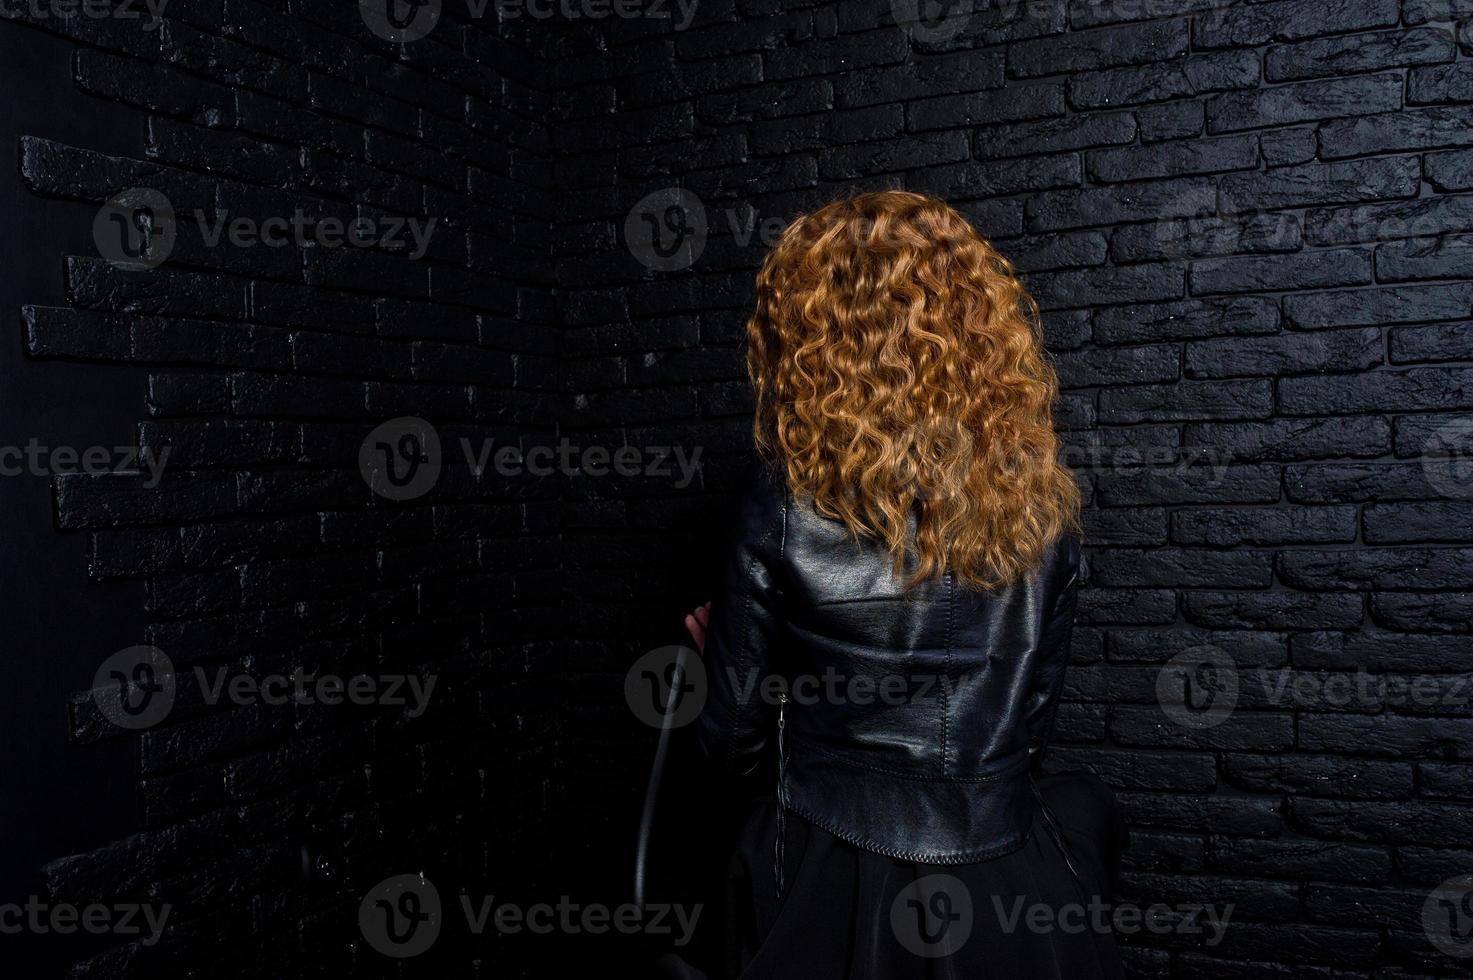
[552,0,1473,979]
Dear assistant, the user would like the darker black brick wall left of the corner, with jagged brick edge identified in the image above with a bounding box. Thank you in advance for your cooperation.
[0,0,566,977]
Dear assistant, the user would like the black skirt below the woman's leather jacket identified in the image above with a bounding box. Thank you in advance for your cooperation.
[722,774,1124,980]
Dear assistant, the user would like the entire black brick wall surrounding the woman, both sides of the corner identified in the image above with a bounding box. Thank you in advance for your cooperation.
[0,0,1473,979]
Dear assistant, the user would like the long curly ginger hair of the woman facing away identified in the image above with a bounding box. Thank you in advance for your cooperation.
[747,190,1080,589]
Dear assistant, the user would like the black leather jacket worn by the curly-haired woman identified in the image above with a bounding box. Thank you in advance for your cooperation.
[697,469,1080,864]
